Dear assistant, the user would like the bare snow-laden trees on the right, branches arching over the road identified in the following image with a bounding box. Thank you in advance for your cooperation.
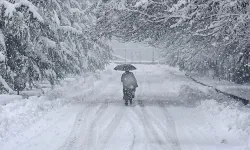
[96,0,250,83]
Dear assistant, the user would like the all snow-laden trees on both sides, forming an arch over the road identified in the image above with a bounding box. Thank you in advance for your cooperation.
[0,0,250,93]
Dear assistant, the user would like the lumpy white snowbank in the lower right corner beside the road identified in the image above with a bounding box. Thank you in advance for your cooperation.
[198,100,250,149]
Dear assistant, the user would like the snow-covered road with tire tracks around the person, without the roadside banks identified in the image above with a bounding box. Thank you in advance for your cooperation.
[0,65,246,150]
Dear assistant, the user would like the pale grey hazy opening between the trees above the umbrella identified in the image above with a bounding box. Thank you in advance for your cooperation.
[111,40,159,61]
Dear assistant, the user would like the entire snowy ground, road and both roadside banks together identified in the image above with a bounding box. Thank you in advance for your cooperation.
[0,64,250,150]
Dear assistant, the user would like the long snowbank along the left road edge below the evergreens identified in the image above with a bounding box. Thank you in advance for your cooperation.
[0,72,109,145]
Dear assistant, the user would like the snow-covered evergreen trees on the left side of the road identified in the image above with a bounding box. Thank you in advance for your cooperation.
[0,0,111,93]
